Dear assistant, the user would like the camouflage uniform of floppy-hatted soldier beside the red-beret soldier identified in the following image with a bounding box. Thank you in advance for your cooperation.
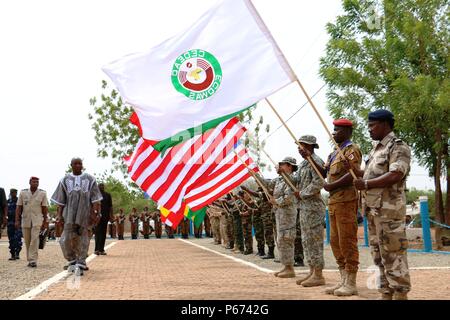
[297,154,325,269]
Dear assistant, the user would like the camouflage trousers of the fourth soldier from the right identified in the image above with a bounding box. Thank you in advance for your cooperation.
[275,206,297,266]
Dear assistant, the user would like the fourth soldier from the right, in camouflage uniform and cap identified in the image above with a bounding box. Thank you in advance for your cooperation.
[272,157,298,278]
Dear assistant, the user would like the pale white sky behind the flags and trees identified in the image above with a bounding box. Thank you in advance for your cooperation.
[0,0,434,193]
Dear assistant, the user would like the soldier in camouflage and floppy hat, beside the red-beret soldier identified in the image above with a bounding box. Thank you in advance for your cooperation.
[297,135,325,287]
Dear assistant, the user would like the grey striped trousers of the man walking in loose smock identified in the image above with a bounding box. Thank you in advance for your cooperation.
[59,223,91,264]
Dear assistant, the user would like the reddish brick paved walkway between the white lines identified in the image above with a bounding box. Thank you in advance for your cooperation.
[35,239,450,300]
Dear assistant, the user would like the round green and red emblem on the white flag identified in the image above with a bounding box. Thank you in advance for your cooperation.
[172,49,222,100]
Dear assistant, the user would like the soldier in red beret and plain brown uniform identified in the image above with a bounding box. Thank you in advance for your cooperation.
[324,119,362,296]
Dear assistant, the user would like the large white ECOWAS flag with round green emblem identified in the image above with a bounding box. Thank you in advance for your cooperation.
[103,0,295,151]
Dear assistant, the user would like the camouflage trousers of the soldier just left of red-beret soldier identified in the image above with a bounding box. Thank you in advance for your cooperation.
[300,207,325,269]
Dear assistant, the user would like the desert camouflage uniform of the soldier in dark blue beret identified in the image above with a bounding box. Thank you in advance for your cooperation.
[363,132,411,293]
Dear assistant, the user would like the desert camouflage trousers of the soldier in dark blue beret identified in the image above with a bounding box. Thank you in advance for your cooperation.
[366,209,411,293]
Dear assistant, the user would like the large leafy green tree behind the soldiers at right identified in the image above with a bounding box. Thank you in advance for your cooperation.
[320,0,450,223]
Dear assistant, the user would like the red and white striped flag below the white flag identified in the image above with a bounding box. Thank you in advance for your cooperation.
[125,118,256,214]
